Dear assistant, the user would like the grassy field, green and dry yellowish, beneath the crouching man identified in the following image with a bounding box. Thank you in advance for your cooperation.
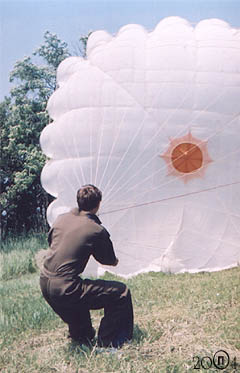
[0,235,240,373]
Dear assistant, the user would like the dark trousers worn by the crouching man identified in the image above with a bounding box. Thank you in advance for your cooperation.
[40,277,133,347]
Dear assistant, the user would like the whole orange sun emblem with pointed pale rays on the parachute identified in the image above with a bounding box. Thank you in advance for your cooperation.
[161,132,212,183]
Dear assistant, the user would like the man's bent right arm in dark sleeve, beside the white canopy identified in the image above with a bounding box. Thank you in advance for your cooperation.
[92,228,118,266]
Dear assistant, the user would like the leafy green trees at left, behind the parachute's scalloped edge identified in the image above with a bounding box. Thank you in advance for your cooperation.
[0,31,70,237]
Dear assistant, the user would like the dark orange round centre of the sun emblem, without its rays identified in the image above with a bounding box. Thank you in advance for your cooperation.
[171,142,203,173]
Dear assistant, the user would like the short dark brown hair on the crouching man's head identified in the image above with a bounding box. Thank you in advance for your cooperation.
[77,184,102,211]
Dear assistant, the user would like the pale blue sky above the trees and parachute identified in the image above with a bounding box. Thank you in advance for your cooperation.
[0,0,240,100]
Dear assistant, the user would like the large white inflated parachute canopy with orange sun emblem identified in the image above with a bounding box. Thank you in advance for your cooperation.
[41,17,240,276]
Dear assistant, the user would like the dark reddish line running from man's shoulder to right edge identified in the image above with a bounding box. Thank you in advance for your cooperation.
[99,180,240,216]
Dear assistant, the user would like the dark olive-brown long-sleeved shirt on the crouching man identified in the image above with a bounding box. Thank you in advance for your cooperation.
[42,208,117,277]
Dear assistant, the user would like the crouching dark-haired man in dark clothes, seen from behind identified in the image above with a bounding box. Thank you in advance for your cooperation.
[40,184,133,347]
